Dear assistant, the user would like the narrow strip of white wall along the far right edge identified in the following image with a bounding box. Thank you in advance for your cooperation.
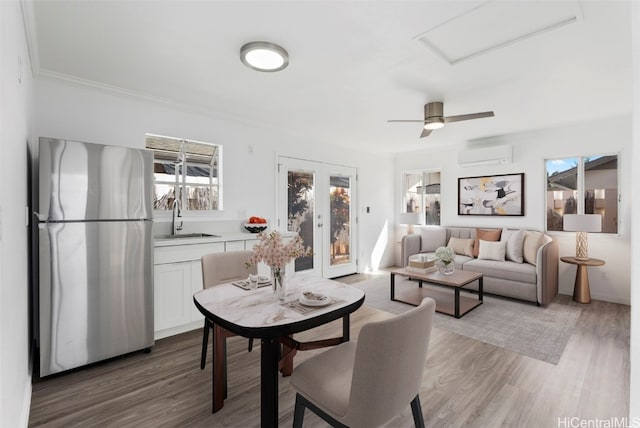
[629,2,640,426]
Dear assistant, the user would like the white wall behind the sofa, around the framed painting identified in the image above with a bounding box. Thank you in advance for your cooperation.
[394,116,632,304]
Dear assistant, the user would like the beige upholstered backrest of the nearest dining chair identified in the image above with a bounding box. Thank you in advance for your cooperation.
[346,297,436,426]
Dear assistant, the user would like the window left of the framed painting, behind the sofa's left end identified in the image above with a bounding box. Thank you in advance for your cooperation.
[401,171,440,225]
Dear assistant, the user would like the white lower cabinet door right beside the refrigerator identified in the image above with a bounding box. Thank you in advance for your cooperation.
[153,262,193,331]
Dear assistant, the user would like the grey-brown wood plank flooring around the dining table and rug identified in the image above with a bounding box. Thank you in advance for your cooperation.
[29,275,630,428]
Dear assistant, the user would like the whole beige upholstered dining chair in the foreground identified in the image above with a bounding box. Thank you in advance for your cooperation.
[291,297,436,428]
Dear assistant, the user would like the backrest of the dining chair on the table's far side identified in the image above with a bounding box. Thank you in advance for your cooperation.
[202,251,258,288]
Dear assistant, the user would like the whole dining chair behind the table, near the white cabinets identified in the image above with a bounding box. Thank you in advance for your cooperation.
[200,251,258,369]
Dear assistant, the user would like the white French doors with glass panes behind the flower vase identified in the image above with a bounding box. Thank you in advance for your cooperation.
[277,156,358,278]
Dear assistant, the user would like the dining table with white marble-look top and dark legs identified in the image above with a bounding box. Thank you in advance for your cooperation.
[193,273,365,427]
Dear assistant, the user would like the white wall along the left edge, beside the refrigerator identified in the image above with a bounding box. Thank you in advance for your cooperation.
[0,1,33,427]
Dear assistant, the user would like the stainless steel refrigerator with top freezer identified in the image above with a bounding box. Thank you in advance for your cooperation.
[36,138,154,377]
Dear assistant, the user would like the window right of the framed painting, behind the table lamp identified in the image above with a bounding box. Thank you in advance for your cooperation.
[545,155,619,233]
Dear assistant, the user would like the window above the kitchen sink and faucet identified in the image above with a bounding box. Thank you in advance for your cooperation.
[146,134,222,211]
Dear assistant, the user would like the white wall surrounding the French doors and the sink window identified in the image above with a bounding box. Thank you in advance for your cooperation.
[35,78,394,271]
